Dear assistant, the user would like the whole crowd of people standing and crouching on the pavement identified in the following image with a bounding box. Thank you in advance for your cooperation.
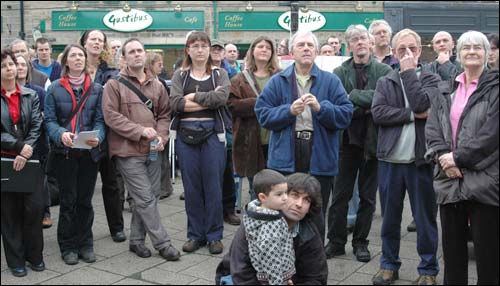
[1,16,499,285]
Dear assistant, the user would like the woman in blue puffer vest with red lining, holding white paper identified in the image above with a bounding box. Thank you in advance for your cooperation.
[45,45,105,265]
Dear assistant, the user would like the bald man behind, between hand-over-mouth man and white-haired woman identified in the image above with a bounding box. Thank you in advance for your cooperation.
[423,31,462,80]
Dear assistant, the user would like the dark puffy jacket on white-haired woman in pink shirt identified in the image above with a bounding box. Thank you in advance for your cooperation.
[425,69,499,207]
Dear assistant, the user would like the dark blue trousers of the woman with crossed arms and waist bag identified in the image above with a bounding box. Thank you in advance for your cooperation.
[175,121,226,242]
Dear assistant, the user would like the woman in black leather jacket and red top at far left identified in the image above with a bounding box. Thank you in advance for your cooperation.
[1,50,45,277]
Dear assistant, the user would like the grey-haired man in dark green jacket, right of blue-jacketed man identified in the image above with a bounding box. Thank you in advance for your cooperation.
[325,25,392,262]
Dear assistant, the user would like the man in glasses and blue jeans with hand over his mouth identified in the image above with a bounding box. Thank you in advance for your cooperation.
[372,29,440,285]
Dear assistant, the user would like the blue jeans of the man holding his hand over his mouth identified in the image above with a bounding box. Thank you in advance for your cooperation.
[378,161,439,275]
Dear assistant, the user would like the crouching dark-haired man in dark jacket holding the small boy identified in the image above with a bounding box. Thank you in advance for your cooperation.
[215,173,328,285]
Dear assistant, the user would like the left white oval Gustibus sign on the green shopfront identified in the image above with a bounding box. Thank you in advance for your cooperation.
[102,9,153,32]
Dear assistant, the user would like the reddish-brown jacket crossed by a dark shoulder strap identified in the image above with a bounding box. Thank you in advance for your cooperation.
[102,69,170,157]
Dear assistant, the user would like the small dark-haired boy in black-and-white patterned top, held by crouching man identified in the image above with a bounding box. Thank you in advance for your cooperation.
[243,169,297,285]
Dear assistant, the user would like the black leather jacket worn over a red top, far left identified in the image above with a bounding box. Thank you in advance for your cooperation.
[1,87,43,154]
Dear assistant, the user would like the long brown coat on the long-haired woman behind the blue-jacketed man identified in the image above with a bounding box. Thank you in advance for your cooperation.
[227,73,272,177]
